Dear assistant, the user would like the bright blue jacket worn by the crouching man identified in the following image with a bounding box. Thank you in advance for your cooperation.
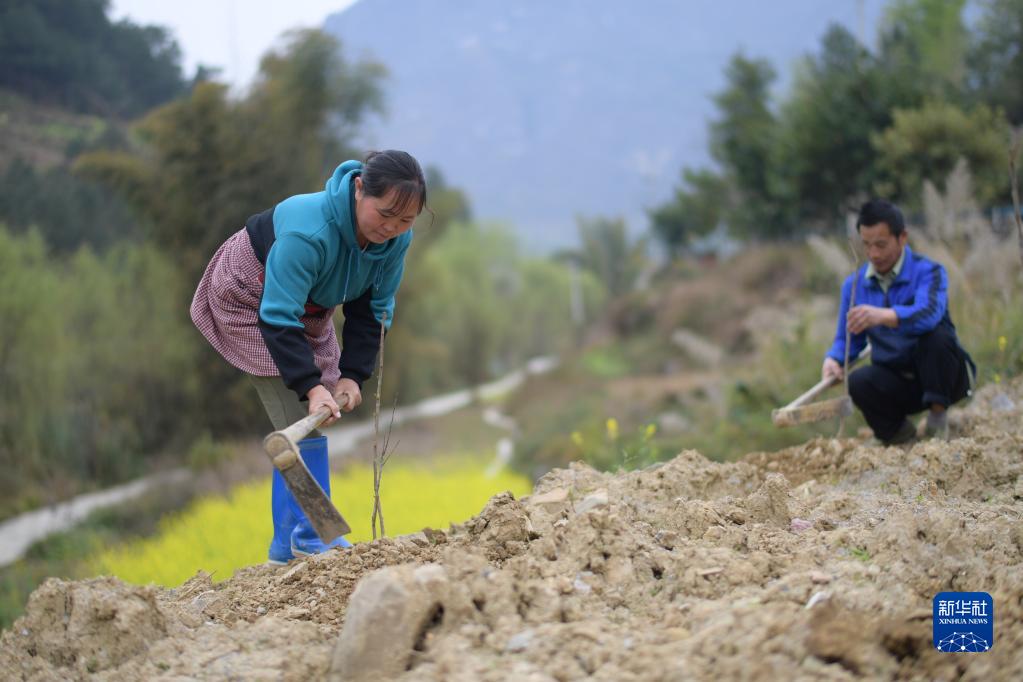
[828,246,955,369]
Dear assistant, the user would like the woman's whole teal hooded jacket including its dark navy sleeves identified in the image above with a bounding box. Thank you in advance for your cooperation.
[246,161,412,398]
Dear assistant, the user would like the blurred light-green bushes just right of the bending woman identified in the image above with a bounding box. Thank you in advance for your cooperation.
[384,224,604,402]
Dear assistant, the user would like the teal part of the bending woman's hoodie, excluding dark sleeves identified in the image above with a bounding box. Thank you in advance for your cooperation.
[259,161,412,328]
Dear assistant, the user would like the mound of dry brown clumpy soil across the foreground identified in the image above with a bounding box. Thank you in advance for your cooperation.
[0,379,1023,682]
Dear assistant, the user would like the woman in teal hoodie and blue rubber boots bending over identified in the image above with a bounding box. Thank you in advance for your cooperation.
[191,149,427,563]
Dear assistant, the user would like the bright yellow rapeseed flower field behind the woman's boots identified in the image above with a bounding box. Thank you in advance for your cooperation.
[90,459,532,587]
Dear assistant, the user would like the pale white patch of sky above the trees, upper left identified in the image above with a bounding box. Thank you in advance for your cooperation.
[110,0,355,87]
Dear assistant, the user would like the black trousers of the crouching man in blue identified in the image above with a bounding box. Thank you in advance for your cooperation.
[849,326,971,441]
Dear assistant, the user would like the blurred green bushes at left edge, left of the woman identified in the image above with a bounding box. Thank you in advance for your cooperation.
[0,227,197,508]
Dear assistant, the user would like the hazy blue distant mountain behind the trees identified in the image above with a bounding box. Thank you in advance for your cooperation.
[324,0,881,251]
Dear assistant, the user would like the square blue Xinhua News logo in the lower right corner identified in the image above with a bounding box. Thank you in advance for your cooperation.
[933,592,994,653]
